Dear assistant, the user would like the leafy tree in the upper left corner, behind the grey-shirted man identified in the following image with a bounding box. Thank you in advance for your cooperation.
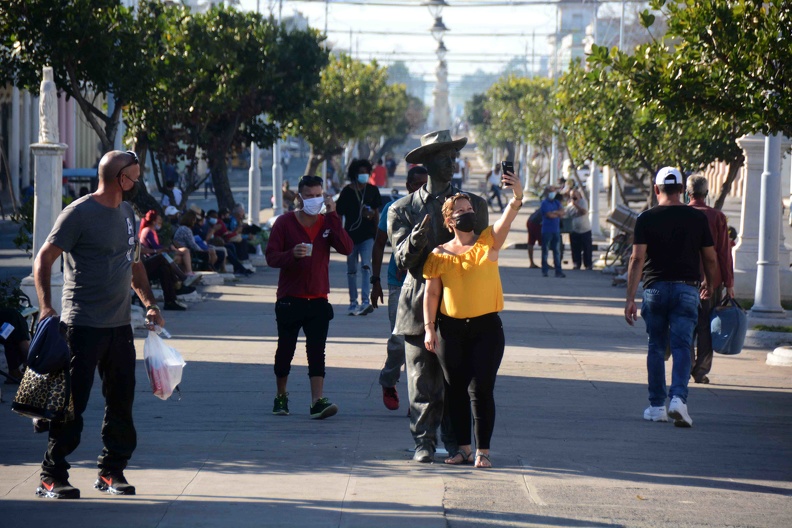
[0,0,147,152]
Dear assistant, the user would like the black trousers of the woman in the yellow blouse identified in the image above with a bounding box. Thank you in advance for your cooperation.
[437,313,506,449]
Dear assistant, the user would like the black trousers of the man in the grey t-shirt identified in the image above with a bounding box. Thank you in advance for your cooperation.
[41,325,137,480]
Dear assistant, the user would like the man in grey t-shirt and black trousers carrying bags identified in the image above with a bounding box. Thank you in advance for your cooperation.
[33,151,165,499]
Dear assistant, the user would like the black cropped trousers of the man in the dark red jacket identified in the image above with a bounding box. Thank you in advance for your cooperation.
[275,297,333,378]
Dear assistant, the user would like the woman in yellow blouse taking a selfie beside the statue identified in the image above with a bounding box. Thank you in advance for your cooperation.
[423,173,522,468]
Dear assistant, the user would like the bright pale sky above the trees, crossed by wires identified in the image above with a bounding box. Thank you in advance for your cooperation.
[235,0,556,82]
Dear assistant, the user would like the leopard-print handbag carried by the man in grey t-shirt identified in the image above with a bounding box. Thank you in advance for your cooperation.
[11,368,74,422]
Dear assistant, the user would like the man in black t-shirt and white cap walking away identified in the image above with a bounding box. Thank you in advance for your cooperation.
[624,167,717,427]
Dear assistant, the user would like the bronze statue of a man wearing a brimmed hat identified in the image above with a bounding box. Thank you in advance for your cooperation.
[388,130,489,463]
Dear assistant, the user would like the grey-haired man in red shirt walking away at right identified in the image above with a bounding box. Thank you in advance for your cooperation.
[687,176,734,383]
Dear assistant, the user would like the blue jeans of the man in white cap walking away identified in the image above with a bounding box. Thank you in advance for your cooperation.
[641,282,699,407]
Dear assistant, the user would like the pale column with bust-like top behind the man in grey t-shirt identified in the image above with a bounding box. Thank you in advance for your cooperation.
[21,67,68,313]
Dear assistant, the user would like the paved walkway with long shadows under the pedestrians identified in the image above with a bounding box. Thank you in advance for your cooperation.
[0,200,792,528]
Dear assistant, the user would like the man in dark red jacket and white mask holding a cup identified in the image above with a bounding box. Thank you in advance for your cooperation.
[265,176,353,420]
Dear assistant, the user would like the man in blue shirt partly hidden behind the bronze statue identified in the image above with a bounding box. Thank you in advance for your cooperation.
[371,165,429,411]
